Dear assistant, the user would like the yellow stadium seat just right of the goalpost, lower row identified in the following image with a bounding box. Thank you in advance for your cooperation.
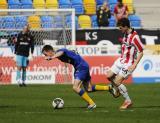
[78,15,91,29]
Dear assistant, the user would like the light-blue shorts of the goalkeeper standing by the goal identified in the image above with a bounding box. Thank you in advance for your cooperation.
[16,55,28,67]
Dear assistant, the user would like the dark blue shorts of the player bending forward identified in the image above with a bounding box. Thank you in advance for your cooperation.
[74,62,91,82]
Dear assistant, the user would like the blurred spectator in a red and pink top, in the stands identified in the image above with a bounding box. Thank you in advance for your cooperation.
[114,0,128,22]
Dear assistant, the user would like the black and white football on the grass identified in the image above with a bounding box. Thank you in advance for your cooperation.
[52,98,64,109]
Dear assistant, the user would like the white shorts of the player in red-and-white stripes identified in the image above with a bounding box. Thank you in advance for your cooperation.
[111,58,132,78]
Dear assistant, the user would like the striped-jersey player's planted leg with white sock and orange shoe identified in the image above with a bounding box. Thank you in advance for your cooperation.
[114,69,132,109]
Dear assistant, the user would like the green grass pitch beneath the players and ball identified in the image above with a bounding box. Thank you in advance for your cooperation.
[0,84,160,123]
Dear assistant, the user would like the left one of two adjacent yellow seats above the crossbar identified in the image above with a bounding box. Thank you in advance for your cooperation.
[33,0,45,9]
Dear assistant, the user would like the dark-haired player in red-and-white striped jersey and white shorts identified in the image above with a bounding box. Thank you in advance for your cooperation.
[107,18,143,109]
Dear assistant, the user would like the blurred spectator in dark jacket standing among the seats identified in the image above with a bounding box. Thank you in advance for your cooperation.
[96,2,111,27]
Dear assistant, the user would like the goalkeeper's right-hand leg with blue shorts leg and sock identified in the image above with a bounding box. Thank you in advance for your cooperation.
[22,56,28,86]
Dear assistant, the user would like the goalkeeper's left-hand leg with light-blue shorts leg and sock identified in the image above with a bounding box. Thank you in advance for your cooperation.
[16,55,22,86]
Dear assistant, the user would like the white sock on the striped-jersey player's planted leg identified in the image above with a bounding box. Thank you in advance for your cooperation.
[118,84,131,101]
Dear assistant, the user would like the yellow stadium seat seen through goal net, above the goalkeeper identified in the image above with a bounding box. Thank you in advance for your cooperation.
[28,15,41,29]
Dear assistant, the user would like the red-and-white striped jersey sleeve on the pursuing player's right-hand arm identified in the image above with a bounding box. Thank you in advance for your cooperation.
[132,35,144,52]
